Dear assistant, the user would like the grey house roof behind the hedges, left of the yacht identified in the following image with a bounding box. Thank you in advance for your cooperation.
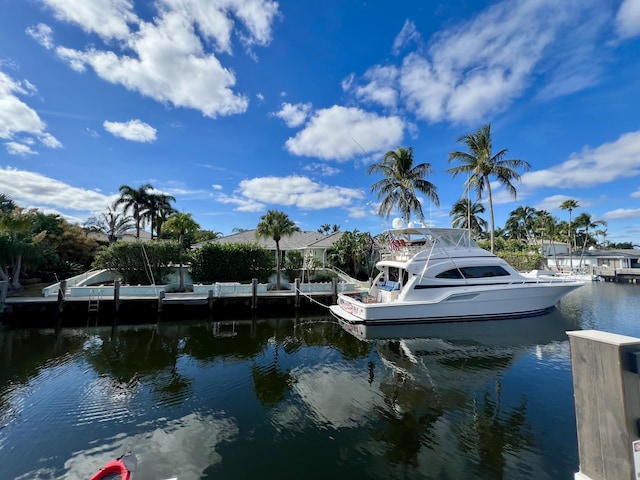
[193,230,342,250]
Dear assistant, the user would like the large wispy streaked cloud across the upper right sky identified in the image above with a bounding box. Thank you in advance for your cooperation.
[342,0,608,124]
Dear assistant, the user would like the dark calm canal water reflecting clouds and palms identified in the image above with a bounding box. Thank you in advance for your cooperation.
[0,282,640,480]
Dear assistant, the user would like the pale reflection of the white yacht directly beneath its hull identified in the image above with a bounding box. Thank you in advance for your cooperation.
[339,309,574,390]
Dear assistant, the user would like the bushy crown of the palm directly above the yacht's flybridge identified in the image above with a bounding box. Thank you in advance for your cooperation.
[367,147,440,223]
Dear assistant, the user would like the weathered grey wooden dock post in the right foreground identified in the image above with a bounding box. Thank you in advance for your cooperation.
[567,330,640,480]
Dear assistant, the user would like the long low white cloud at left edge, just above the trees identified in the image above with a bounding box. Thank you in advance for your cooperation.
[0,167,118,211]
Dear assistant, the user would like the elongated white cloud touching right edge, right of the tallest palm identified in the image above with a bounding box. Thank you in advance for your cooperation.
[522,130,640,188]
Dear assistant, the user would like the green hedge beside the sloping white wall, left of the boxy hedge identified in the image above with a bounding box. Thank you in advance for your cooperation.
[93,241,179,285]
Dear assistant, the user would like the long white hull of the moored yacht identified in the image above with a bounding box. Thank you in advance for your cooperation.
[330,282,584,324]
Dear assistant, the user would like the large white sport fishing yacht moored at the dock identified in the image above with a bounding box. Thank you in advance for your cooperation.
[330,222,585,325]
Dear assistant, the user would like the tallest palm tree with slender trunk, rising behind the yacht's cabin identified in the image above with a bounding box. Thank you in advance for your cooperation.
[447,124,531,253]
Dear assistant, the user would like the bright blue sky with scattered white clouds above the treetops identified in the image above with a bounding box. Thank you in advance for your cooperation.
[0,0,640,243]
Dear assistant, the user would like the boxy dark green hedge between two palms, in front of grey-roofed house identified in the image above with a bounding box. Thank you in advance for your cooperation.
[190,243,275,283]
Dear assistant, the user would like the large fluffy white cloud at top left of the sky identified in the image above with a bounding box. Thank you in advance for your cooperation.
[32,0,278,118]
